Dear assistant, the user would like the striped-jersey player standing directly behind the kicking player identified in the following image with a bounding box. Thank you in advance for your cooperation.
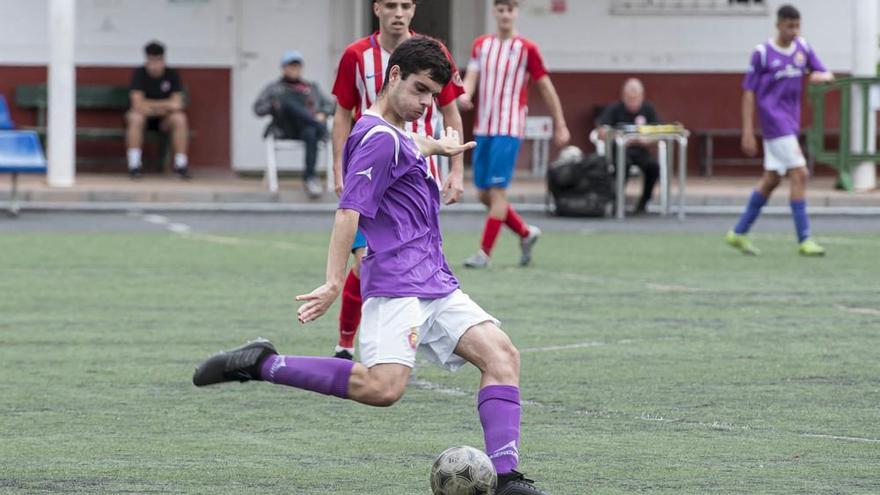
[333,0,464,359]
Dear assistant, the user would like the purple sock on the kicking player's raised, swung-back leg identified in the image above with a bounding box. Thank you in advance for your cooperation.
[260,354,354,399]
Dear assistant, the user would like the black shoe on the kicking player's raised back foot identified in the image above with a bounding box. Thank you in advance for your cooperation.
[193,338,278,387]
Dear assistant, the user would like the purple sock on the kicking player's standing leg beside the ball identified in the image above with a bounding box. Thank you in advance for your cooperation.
[477,385,520,474]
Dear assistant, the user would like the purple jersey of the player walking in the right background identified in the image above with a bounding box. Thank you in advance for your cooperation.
[743,38,826,139]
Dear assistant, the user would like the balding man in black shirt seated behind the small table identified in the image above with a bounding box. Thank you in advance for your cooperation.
[596,78,660,213]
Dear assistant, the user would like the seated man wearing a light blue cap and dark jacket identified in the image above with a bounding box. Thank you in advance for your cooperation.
[254,50,333,198]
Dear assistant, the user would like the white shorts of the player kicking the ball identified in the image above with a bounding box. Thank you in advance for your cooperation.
[358,289,500,371]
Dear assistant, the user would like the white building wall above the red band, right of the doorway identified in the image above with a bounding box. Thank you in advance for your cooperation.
[506,0,856,72]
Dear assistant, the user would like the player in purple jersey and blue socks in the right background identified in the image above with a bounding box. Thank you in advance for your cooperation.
[726,5,834,256]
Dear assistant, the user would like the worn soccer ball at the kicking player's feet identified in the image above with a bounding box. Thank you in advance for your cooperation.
[431,445,498,495]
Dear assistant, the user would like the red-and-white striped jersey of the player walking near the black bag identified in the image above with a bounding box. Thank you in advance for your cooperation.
[468,34,547,138]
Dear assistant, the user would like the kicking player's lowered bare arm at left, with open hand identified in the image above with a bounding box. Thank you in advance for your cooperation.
[296,209,360,323]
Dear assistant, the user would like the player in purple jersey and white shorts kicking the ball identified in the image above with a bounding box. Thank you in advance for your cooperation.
[193,37,544,495]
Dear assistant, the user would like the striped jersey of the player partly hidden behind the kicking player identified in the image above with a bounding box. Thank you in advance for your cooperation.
[333,32,464,180]
